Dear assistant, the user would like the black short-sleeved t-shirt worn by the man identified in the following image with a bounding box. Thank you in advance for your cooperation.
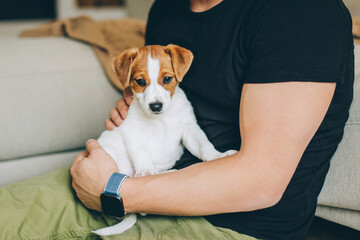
[146,0,354,239]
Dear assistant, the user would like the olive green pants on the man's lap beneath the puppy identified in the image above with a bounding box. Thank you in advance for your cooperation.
[0,168,254,240]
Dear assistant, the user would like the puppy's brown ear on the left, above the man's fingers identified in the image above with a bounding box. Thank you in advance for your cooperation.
[112,48,138,88]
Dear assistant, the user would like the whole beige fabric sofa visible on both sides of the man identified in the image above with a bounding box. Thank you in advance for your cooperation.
[0,20,360,230]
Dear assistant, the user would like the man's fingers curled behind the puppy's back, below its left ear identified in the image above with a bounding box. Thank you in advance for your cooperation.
[105,88,133,131]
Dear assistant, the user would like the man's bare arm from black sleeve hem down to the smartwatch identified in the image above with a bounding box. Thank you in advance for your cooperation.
[121,82,336,216]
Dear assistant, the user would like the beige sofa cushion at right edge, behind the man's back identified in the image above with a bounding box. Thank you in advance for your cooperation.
[318,45,360,213]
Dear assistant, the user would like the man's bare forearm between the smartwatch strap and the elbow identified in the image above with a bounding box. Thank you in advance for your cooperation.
[121,152,278,216]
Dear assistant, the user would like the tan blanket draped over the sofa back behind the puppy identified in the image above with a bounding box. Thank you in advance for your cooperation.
[20,16,145,90]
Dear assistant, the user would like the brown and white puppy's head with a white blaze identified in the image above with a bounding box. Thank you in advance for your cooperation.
[113,44,193,115]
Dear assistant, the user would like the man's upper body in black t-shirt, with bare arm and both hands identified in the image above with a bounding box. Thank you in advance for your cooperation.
[72,0,353,239]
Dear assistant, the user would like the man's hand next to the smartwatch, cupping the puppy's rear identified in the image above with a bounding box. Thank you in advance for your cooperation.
[70,139,119,211]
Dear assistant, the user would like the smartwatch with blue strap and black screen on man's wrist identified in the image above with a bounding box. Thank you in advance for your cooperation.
[100,173,129,217]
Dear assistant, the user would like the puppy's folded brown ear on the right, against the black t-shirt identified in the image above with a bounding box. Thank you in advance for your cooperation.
[165,44,194,82]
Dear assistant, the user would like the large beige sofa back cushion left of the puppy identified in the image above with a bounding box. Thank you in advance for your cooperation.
[0,23,121,161]
